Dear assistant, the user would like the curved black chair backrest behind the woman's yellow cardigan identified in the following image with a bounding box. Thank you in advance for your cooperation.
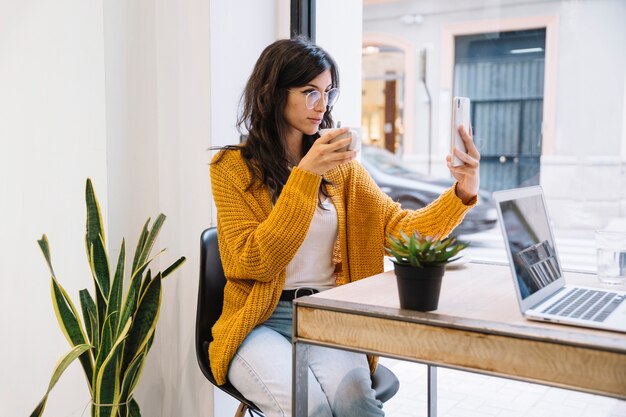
[196,227,258,410]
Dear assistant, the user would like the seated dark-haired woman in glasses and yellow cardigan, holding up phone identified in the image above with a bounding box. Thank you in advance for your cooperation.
[209,38,480,417]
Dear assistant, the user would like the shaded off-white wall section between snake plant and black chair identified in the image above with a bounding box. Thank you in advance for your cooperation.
[104,0,212,417]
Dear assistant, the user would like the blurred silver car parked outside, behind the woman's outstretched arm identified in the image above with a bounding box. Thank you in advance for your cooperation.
[361,146,498,235]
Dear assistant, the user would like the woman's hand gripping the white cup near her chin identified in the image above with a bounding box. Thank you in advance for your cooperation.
[298,127,356,175]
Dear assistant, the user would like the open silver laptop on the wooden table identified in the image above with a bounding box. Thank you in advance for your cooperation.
[493,186,626,332]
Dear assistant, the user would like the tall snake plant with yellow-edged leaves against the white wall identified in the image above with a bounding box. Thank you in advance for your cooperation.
[31,179,185,417]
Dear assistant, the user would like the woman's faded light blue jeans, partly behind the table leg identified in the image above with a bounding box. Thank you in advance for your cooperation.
[228,301,385,417]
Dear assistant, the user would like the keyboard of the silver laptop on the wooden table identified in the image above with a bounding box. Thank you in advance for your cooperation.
[542,288,626,322]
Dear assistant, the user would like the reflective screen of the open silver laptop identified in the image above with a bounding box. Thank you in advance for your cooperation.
[498,189,562,300]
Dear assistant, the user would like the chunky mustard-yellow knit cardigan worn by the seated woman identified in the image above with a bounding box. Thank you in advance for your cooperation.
[209,150,476,385]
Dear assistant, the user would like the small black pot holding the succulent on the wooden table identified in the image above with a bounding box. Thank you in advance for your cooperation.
[393,263,446,311]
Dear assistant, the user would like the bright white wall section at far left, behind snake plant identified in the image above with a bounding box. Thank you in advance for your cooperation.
[0,0,107,416]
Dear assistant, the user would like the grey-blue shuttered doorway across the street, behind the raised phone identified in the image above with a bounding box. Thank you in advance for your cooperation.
[454,29,546,191]
